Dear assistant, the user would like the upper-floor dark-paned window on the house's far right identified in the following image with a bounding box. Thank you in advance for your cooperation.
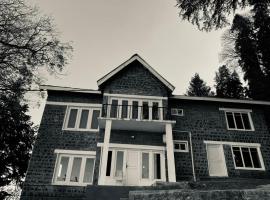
[225,111,254,131]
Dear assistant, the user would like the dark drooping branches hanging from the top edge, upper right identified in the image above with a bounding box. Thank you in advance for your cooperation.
[177,0,270,31]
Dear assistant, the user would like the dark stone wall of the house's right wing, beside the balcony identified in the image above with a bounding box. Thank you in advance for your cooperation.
[169,100,270,180]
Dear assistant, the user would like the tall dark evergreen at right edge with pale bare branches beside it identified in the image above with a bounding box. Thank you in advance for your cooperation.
[222,13,270,100]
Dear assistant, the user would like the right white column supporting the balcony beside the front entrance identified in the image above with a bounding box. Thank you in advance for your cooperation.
[166,123,176,182]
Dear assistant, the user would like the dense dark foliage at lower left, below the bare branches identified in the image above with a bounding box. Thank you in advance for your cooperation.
[0,84,36,196]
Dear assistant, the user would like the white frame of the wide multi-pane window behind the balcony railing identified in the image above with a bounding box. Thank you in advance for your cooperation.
[107,96,163,121]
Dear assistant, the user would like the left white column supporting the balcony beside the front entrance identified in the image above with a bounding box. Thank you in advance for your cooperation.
[98,120,112,185]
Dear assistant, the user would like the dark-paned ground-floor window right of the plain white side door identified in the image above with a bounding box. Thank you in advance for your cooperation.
[232,146,264,169]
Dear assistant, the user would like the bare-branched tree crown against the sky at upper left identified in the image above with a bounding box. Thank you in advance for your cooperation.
[0,0,72,88]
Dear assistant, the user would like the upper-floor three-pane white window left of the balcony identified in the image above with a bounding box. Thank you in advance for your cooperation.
[64,107,100,131]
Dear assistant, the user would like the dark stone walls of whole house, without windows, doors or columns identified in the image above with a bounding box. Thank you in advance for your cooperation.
[21,61,270,200]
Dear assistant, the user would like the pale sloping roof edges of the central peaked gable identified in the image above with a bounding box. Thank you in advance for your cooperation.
[97,54,175,91]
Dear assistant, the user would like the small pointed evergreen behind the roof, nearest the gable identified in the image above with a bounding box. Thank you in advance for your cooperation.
[186,73,211,97]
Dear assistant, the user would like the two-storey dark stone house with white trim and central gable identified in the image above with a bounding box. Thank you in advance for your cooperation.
[21,54,270,200]
